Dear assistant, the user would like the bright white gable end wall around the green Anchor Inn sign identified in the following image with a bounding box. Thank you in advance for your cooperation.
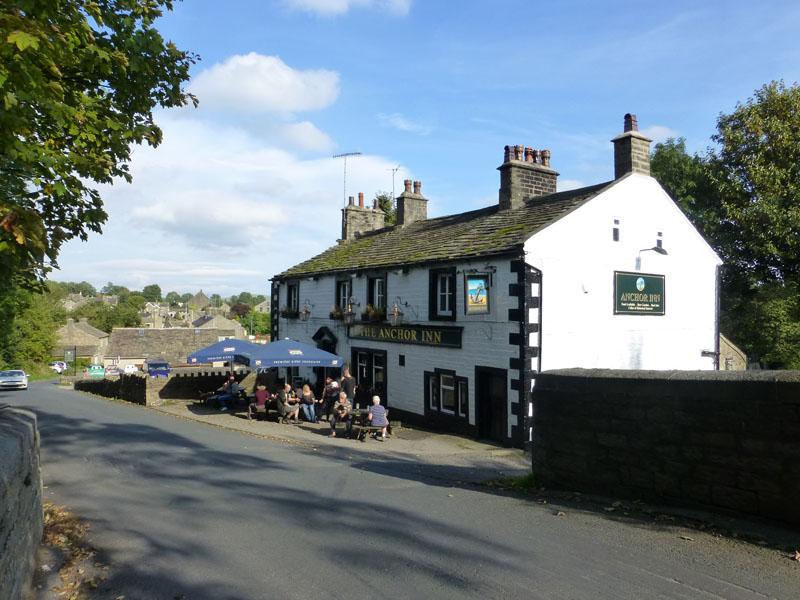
[525,175,721,370]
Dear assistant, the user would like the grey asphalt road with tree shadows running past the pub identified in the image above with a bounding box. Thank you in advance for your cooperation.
[7,382,800,600]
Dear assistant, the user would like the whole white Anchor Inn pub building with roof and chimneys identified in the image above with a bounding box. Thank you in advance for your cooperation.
[271,115,721,447]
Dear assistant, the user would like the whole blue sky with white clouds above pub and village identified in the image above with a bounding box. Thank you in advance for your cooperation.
[50,0,800,297]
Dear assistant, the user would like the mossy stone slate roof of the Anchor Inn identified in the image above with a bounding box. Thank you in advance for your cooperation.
[274,182,613,279]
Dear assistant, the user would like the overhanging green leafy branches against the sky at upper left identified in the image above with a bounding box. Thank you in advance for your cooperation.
[0,0,197,289]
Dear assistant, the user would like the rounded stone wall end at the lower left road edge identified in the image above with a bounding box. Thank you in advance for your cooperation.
[0,407,44,598]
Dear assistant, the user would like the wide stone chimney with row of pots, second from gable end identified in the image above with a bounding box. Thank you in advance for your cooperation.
[497,146,558,210]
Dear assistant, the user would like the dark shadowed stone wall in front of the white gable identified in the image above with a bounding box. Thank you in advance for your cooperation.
[532,369,800,525]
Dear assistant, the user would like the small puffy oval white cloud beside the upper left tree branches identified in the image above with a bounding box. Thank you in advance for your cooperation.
[189,52,339,113]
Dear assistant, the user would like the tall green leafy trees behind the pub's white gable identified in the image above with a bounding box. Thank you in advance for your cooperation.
[651,82,800,368]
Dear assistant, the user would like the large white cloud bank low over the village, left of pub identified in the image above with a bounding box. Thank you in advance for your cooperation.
[53,111,406,295]
